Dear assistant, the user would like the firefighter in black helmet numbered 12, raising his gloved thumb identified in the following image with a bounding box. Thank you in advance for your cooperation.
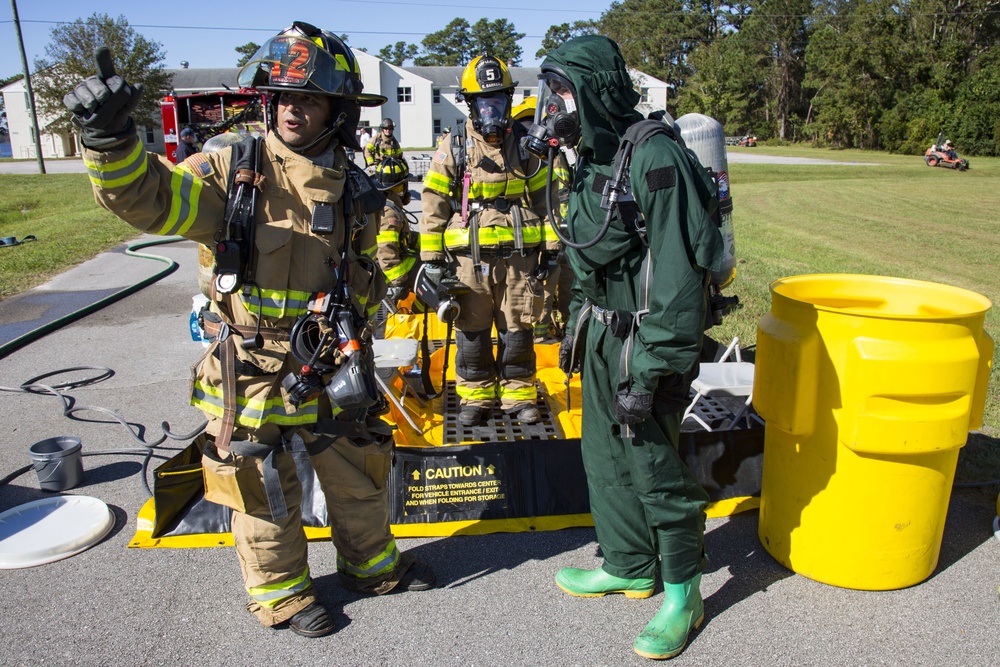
[64,22,435,637]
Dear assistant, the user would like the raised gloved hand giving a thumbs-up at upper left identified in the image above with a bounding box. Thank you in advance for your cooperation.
[63,46,142,150]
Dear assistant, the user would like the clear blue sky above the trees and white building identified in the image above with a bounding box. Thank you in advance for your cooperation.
[0,0,611,77]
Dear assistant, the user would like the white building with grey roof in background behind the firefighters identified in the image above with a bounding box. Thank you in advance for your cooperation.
[0,51,667,159]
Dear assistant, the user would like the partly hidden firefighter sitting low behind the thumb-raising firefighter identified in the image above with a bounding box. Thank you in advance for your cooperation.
[375,158,420,307]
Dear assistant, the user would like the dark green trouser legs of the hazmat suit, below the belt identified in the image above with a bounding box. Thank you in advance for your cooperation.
[581,321,708,584]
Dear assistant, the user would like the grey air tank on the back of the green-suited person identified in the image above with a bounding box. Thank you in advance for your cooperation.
[675,113,736,289]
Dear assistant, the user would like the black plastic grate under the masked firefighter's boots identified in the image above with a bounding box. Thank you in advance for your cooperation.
[442,380,562,445]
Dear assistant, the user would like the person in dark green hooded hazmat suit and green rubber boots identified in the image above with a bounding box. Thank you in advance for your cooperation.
[533,35,723,659]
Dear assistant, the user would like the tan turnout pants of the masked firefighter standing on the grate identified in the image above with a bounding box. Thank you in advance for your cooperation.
[455,250,542,412]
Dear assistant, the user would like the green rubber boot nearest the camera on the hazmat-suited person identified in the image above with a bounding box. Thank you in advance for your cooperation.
[634,574,705,660]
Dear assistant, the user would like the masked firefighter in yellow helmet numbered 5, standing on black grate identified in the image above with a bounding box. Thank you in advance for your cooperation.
[420,55,558,426]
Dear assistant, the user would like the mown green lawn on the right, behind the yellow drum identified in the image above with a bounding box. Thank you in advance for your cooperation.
[711,148,1000,478]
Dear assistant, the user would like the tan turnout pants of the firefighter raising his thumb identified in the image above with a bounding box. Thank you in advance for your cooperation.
[203,424,405,626]
